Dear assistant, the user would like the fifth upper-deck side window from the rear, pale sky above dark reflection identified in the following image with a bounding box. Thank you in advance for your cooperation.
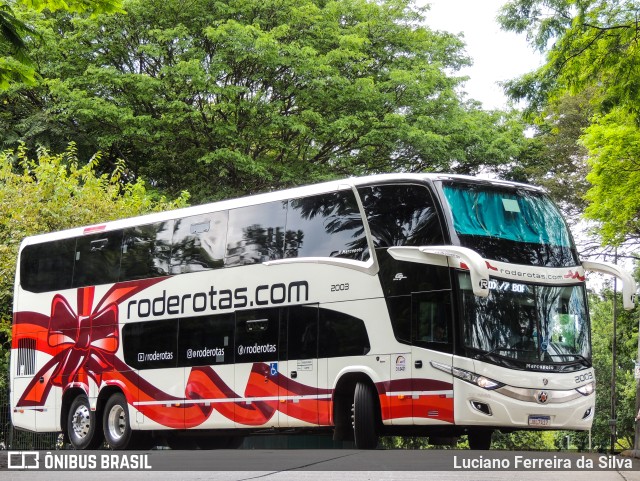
[224,201,287,267]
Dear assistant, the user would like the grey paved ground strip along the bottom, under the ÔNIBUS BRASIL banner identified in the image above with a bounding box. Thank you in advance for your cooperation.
[0,450,640,481]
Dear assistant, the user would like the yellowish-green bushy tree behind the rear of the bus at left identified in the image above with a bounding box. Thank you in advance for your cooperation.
[0,145,188,378]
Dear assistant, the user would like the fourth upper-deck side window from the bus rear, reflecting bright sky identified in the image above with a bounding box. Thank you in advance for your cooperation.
[171,211,229,274]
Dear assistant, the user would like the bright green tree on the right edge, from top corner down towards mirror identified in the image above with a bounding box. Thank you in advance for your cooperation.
[500,0,640,245]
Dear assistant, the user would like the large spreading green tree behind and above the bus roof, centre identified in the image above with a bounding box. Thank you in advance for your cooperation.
[0,0,523,202]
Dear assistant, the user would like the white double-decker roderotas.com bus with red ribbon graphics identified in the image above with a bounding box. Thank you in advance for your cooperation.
[10,174,636,449]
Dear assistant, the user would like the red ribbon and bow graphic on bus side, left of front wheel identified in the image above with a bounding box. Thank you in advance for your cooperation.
[12,278,332,429]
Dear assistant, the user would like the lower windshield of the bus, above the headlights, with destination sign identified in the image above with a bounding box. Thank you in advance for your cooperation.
[459,273,591,370]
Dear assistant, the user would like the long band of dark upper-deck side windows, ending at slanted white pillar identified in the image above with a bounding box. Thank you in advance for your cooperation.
[20,190,369,292]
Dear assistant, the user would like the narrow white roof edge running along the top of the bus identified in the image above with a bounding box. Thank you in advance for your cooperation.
[21,173,544,248]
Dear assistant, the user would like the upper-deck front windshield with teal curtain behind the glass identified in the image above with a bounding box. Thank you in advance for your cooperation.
[443,184,578,267]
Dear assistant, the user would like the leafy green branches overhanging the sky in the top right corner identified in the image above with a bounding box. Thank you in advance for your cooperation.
[499,0,640,116]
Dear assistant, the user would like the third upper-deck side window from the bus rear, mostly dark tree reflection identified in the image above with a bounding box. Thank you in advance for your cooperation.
[120,221,173,281]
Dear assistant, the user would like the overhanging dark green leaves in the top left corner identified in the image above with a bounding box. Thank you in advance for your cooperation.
[0,0,122,89]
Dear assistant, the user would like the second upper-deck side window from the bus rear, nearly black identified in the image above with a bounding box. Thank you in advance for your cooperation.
[73,230,123,287]
